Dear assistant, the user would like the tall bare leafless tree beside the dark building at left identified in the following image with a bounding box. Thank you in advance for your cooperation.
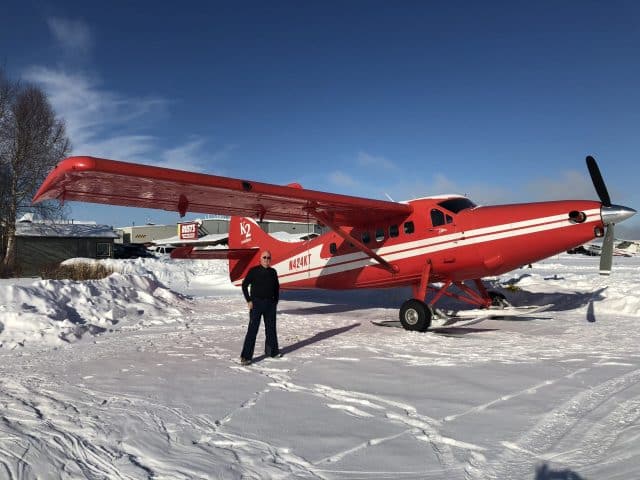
[0,68,70,268]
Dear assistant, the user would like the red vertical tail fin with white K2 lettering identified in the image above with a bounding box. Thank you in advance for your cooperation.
[229,217,292,282]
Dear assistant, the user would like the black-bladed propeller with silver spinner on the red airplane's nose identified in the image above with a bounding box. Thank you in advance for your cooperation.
[587,155,636,275]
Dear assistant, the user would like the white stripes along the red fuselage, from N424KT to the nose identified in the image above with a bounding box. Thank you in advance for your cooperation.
[238,209,600,286]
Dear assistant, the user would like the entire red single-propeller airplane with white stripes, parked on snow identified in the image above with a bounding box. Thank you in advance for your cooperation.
[33,156,636,331]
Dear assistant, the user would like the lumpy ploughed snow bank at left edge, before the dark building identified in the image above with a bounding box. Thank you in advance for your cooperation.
[0,273,189,348]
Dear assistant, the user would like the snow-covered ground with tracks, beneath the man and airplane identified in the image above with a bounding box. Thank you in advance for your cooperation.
[0,255,640,480]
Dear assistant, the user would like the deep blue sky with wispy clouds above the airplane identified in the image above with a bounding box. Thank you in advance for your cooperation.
[0,0,640,238]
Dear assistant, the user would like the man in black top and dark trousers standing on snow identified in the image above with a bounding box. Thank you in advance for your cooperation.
[240,250,282,365]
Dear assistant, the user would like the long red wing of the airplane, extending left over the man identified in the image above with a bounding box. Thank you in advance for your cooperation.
[33,157,412,226]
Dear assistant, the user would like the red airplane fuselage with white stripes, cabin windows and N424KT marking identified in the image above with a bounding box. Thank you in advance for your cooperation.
[231,197,603,289]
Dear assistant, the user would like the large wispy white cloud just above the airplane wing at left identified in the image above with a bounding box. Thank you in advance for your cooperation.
[23,67,235,172]
